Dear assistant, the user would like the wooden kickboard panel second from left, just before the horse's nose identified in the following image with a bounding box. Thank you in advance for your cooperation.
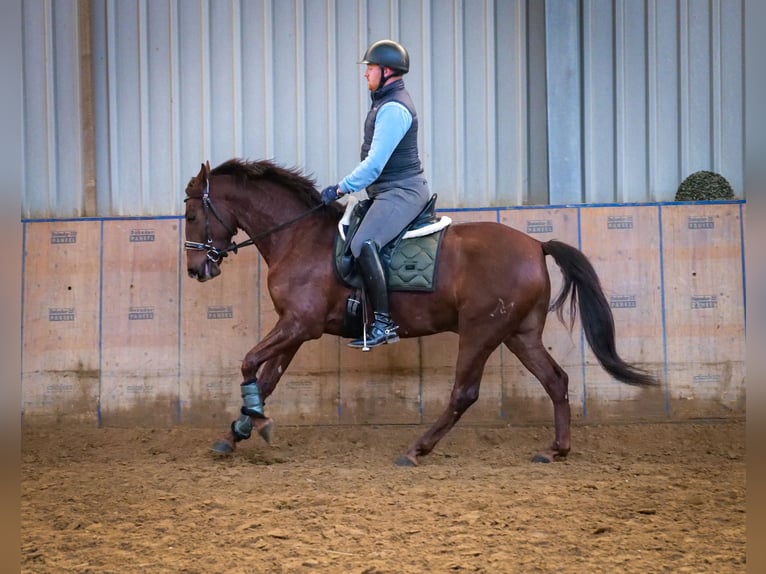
[101,219,181,426]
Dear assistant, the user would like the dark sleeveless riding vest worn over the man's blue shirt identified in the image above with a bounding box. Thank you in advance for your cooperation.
[362,80,423,183]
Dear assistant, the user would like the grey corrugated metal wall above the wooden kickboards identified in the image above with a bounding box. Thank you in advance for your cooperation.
[22,0,745,218]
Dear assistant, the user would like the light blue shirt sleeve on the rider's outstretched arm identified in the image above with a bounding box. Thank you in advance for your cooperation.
[338,102,412,193]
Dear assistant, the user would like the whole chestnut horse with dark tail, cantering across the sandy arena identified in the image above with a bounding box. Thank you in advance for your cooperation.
[184,158,658,466]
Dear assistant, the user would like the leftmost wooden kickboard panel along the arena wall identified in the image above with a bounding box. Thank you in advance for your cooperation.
[22,221,101,419]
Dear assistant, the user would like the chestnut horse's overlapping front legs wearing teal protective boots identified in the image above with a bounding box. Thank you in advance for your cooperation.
[212,329,303,454]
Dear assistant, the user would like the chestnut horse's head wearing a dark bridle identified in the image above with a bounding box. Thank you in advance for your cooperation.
[184,162,237,281]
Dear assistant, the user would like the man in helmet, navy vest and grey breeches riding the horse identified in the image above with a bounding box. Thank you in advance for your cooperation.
[322,40,431,348]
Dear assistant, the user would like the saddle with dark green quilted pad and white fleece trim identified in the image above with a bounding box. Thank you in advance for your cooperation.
[333,194,452,337]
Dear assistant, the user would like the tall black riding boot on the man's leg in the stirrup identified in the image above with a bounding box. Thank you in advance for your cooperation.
[348,239,399,349]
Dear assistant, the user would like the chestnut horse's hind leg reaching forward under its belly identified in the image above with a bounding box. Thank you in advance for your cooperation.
[396,342,496,466]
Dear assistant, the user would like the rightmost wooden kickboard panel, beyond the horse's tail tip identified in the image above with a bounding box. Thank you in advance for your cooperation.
[662,204,745,415]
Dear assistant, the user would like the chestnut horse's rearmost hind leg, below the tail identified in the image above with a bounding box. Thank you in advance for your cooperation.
[505,331,571,462]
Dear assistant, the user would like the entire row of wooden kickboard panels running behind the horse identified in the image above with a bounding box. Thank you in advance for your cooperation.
[22,203,745,428]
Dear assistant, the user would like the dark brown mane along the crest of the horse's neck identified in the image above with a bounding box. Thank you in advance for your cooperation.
[210,158,328,207]
